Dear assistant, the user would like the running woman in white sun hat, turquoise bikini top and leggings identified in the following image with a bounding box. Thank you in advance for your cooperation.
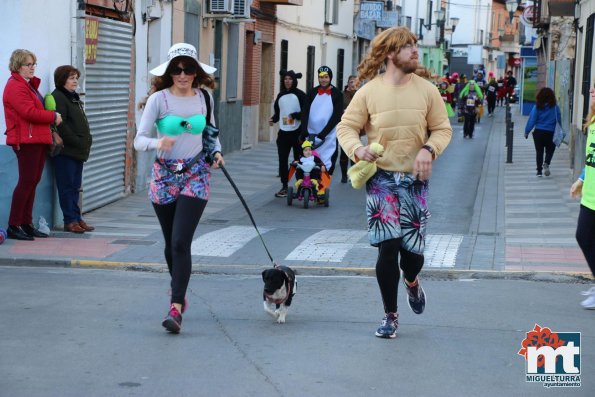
[134,43,225,333]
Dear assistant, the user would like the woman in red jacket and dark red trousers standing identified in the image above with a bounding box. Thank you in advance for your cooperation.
[2,49,62,240]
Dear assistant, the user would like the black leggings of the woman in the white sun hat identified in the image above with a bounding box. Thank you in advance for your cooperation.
[153,196,207,304]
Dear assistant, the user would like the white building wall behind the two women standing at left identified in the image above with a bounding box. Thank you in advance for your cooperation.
[0,0,74,145]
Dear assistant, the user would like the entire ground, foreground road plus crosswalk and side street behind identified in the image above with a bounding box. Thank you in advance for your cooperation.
[0,108,595,397]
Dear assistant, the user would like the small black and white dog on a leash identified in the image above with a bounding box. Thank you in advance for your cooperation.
[262,265,297,324]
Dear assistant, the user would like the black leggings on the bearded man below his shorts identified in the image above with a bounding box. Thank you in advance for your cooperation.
[376,238,424,313]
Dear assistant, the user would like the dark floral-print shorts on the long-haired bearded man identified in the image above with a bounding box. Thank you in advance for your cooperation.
[366,169,430,255]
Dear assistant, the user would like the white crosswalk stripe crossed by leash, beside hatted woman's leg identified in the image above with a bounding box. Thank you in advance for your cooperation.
[190,226,270,258]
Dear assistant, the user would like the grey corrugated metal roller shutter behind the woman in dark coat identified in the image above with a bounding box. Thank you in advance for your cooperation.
[83,18,132,212]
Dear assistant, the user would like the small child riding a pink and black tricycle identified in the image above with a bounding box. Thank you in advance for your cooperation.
[287,140,328,208]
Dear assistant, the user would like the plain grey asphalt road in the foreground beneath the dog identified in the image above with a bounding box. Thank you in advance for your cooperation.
[0,266,595,397]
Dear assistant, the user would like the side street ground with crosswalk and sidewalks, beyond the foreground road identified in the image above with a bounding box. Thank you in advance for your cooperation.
[0,107,589,278]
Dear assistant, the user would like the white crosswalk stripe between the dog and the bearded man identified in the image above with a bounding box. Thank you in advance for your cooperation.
[285,230,367,262]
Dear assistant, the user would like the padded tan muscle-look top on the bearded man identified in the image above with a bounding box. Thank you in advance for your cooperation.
[337,74,452,172]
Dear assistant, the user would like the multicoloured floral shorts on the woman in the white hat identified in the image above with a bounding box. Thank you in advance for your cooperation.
[149,158,211,204]
